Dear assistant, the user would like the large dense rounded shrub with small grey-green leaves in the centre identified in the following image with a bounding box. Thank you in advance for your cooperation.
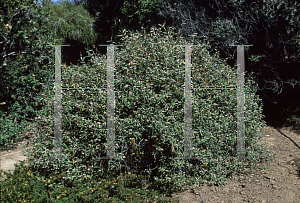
[24,23,264,195]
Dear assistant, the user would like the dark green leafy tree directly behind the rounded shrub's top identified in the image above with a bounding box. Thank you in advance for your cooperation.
[84,0,176,54]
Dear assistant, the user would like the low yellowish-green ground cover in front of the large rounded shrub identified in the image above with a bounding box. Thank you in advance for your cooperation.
[0,161,178,203]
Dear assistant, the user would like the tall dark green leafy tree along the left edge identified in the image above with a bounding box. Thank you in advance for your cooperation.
[0,0,61,121]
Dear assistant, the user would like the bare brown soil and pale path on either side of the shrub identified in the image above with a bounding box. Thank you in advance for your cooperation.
[0,126,300,203]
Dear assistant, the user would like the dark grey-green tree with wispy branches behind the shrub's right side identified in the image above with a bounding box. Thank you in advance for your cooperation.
[158,0,300,126]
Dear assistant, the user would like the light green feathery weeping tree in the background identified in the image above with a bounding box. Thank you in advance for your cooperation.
[36,1,97,64]
